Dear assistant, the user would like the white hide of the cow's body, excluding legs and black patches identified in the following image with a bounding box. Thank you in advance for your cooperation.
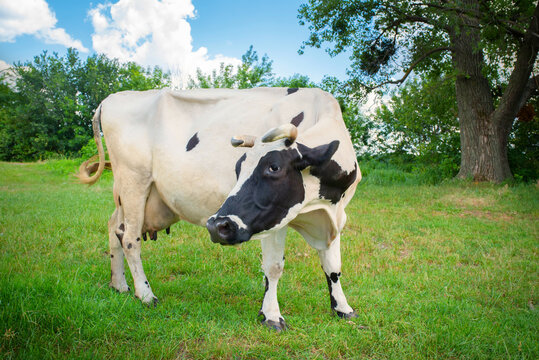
[101,88,361,249]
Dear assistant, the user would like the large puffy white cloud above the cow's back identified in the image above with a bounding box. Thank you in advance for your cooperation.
[89,0,241,87]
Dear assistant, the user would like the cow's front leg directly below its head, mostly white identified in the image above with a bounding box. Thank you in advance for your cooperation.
[259,227,286,331]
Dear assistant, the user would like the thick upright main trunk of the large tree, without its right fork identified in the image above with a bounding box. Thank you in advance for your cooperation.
[450,0,512,182]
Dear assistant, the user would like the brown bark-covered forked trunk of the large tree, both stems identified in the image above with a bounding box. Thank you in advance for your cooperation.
[450,0,537,183]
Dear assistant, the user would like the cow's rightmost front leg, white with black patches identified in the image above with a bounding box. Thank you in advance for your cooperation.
[318,235,357,319]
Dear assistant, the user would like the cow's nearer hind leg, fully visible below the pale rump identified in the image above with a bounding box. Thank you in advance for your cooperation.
[120,174,157,305]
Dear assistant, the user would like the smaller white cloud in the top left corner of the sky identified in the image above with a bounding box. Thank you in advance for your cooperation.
[0,0,88,52]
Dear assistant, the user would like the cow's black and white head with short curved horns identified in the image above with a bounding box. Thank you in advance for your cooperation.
[206,124,339,245]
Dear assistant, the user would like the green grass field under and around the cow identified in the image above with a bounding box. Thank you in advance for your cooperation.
[0,161,539,359]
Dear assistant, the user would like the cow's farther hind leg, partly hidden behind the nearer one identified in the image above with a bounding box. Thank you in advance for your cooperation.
[109,207,130,292]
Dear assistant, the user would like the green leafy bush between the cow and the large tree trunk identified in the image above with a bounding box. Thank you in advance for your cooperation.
[375,78,460,176]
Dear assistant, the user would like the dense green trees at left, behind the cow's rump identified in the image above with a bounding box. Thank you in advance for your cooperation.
[0,49,169,161]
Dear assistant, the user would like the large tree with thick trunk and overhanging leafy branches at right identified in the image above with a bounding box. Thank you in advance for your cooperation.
[299,0,539,182]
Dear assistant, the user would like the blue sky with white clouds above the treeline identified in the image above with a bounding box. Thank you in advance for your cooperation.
[0,0,349,81]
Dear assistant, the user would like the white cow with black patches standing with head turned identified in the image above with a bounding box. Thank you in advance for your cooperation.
[77,88,361,331]
